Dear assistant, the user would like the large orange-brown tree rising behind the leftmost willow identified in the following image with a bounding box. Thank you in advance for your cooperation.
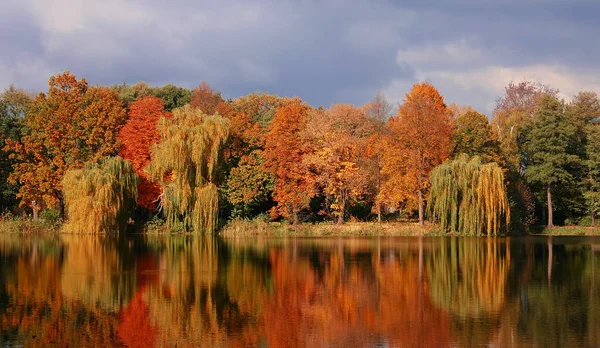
[9,71,126,213]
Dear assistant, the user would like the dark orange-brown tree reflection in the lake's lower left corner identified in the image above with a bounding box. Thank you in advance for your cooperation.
[0,241,119,347]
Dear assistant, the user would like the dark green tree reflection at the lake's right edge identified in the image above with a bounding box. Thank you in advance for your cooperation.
[514,245,600,347]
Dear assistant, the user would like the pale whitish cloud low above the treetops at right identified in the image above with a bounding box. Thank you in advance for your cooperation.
[384,38,600,115]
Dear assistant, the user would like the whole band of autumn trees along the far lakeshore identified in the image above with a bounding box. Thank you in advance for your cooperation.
[0,71,600,235]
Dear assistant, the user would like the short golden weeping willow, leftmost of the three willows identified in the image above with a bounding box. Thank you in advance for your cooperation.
[62,157,139,233]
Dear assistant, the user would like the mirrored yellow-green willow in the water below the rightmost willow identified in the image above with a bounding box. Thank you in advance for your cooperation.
[427,238,510,317]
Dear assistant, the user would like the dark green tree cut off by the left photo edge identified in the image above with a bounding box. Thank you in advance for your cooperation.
[0,85,33,211]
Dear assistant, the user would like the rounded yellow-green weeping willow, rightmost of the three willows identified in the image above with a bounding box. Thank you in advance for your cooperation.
[428,155,510,236]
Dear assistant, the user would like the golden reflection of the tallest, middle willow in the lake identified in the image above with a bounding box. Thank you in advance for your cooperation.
[147,236,226,346]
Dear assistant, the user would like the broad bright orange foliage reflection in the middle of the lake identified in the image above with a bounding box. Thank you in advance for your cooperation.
[263,250,451,347]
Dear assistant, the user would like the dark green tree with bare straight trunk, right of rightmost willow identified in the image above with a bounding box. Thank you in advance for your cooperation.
[523,94,581,228]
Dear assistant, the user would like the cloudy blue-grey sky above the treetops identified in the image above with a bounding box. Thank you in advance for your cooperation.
[0,0,600,115]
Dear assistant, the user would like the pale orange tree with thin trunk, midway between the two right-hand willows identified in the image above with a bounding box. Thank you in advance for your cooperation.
[304,104,372,224]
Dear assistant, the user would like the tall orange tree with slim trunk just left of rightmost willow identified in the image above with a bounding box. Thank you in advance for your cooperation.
[381,82,452,225]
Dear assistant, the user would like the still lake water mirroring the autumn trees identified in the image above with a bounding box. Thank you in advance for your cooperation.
[0,235,600,347]
